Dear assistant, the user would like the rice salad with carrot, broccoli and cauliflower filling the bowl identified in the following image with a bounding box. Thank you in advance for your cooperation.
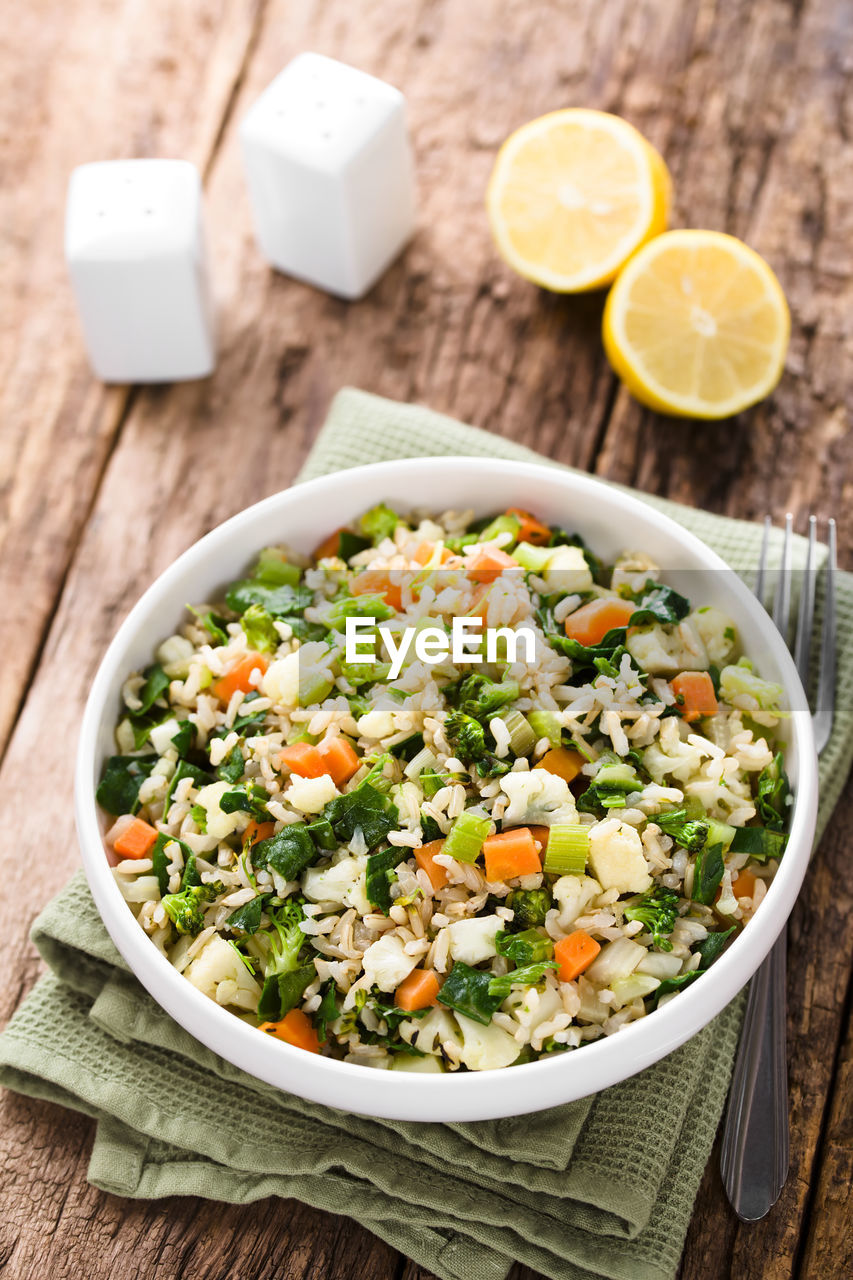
[97,503,790,1071]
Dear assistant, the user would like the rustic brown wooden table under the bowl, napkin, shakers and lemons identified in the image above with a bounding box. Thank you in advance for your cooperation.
[0,0,853,1280]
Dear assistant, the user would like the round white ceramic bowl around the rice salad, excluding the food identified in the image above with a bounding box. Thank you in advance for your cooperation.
[76,458,817,1121]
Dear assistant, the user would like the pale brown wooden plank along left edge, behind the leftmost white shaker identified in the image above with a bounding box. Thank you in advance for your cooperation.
[0,0,260,751]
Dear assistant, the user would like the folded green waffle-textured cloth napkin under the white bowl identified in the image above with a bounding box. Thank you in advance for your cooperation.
[0,390,853,1280]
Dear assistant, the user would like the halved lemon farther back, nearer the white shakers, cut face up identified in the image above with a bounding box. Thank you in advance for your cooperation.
[485,108,671,293]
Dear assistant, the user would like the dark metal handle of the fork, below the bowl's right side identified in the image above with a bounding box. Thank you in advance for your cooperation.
[720,929,789,1222]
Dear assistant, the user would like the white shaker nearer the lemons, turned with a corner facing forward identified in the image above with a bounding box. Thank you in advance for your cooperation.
[240,54,415,298]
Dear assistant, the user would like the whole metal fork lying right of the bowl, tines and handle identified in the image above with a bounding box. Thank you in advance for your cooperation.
[720,515,836,1222]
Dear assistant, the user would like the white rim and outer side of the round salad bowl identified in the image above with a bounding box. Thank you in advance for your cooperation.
[74,454,817,1123]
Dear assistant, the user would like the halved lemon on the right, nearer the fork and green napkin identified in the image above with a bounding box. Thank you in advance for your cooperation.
[602,230,790,419]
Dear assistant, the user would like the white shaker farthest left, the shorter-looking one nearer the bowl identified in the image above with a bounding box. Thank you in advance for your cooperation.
[65,160,215,383]
